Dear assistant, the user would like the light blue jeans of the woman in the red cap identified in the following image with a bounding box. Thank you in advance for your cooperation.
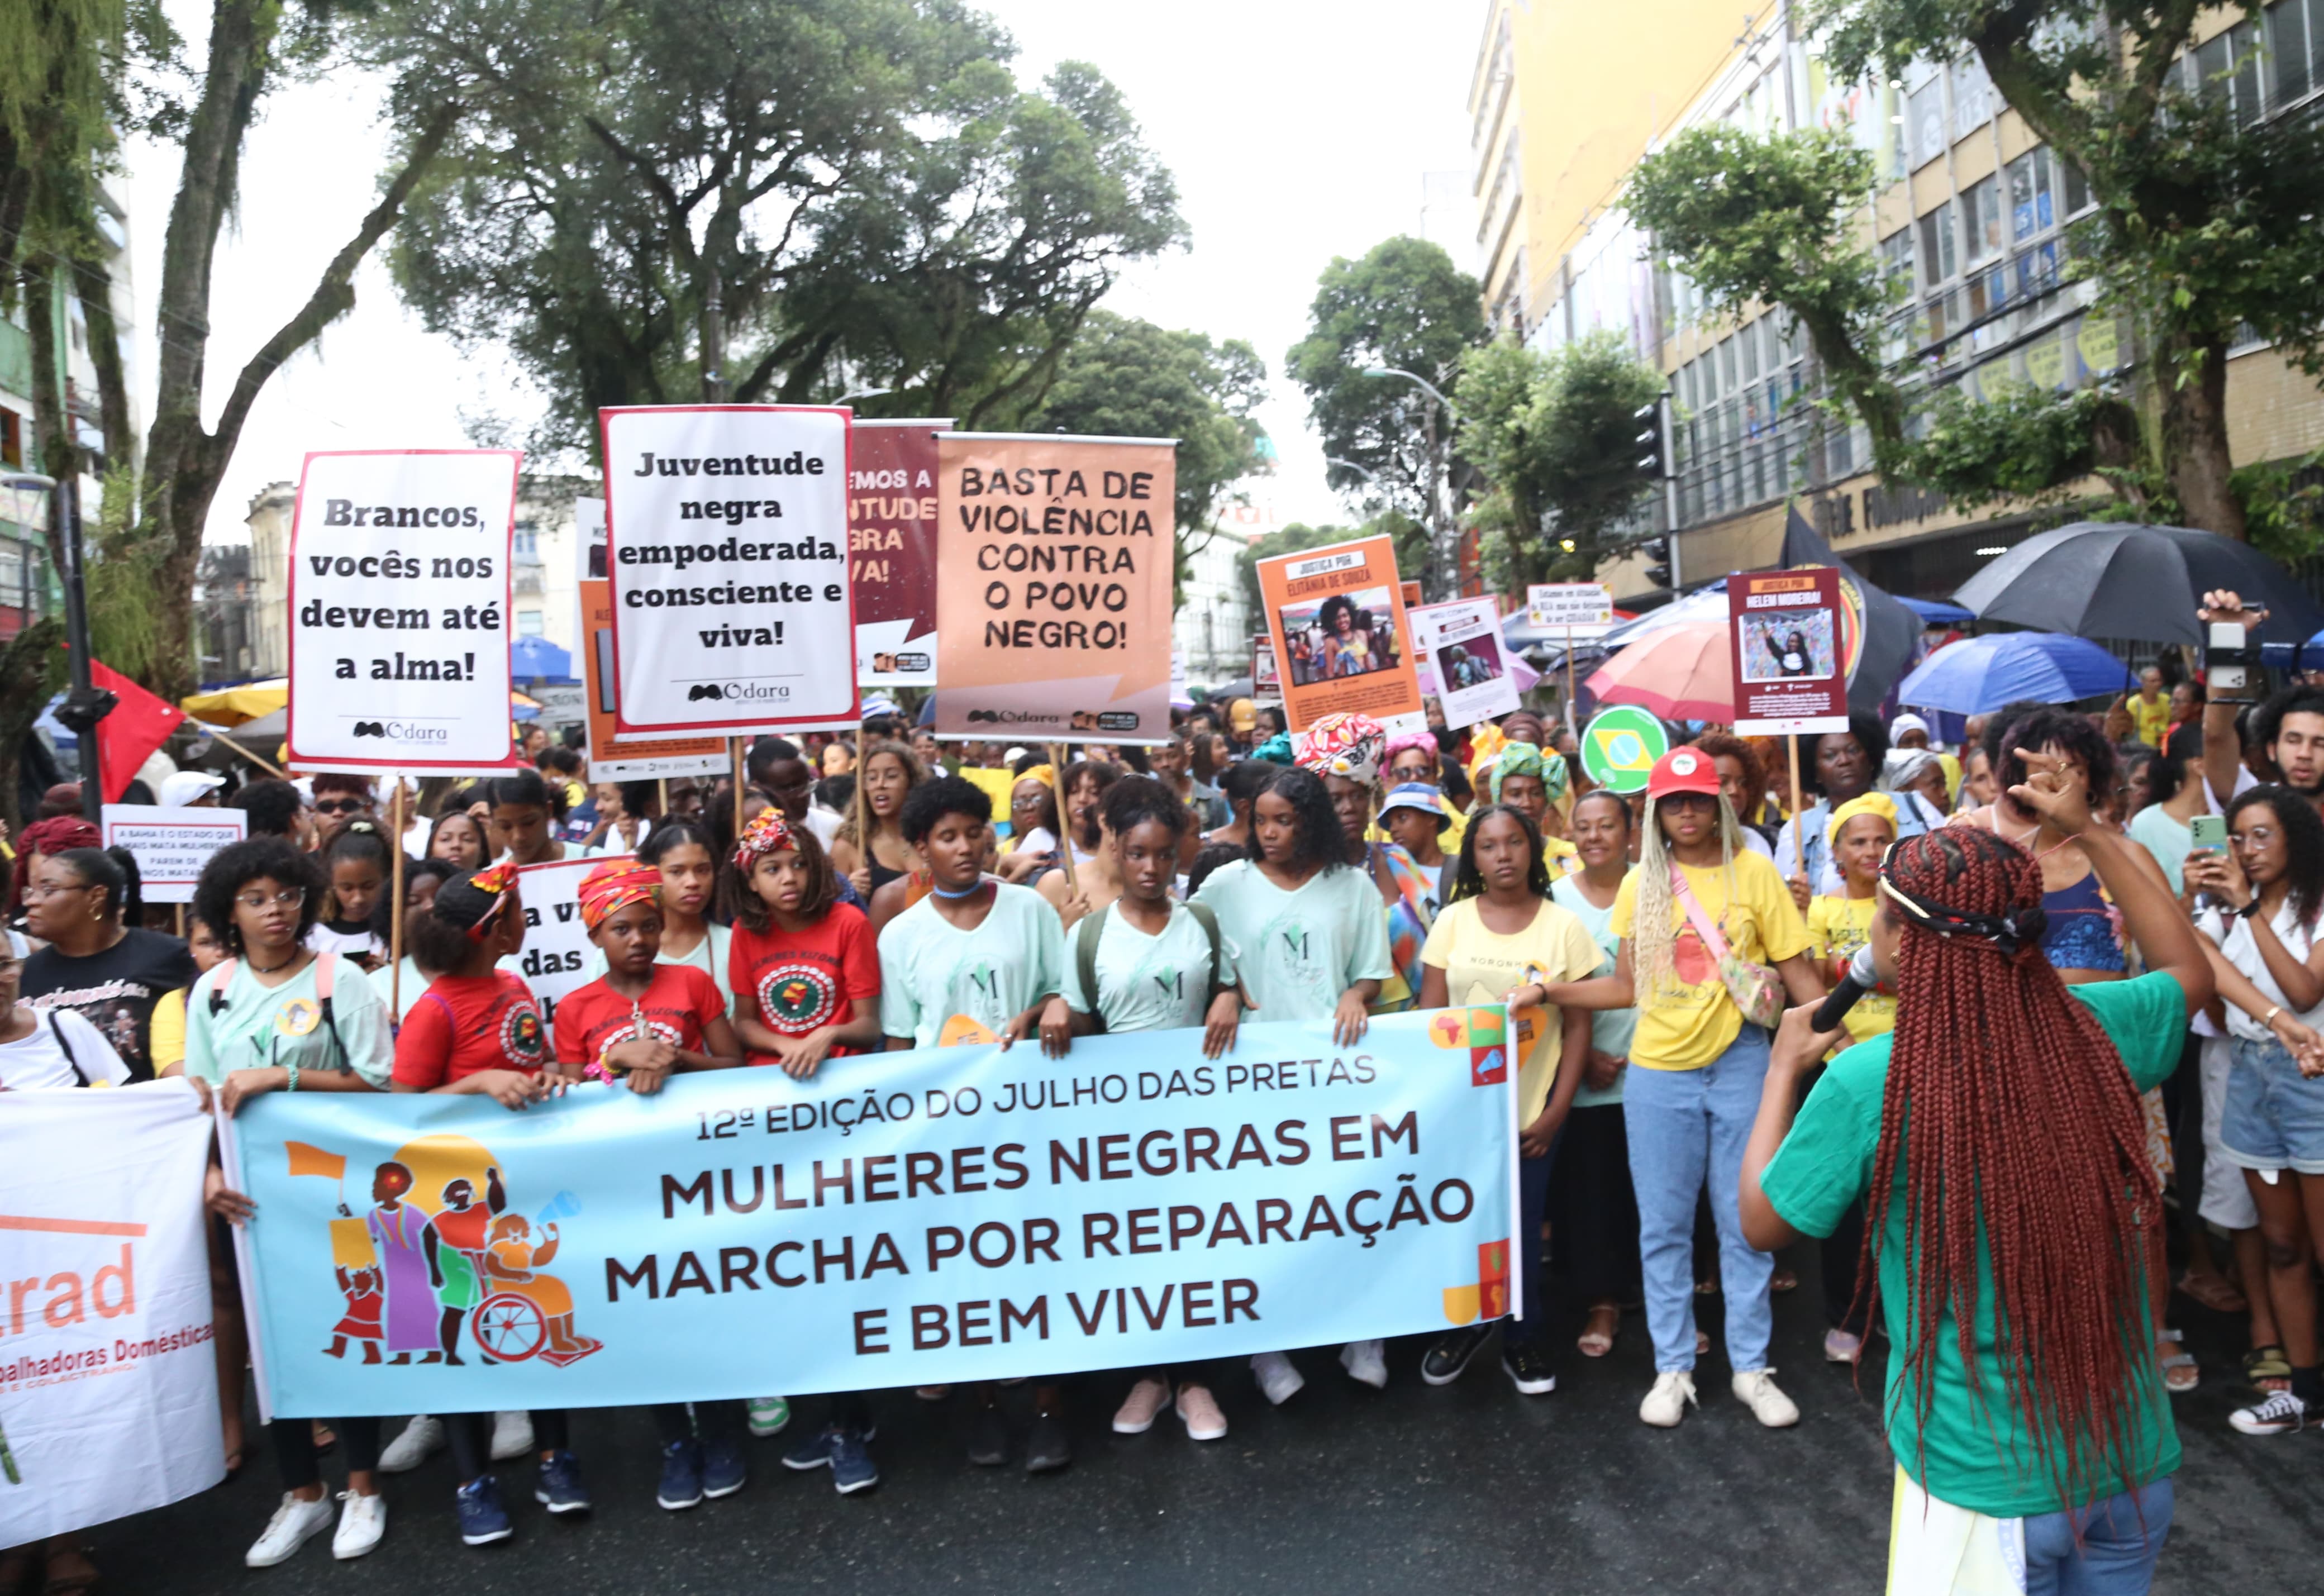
[1622,1025,1775,1373]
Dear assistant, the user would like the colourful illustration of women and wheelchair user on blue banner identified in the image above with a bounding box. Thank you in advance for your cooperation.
[284,1138,604,1368]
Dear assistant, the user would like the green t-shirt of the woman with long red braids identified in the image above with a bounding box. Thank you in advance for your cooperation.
[1759,971,2187,1519]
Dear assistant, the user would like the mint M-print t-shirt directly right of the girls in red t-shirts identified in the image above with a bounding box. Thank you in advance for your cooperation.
[878,883,1064,1048]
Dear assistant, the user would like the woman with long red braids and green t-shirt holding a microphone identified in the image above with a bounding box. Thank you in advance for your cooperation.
[1741,750,2212,1596]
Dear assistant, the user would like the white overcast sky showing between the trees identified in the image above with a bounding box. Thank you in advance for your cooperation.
[123,0,1485,541]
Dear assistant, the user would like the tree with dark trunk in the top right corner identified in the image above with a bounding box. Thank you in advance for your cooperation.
[1813,0,2324,537]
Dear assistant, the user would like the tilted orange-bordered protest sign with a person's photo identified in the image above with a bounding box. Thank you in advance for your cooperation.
[1260,537,1427,734]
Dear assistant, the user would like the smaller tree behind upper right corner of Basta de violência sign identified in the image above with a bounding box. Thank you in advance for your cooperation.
[1027,311,1266,583]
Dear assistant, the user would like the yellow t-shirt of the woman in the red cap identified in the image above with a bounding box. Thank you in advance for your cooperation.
[1608,852,1808,1069]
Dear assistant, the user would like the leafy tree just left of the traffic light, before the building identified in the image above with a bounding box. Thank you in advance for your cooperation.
[1455,332,1664,592]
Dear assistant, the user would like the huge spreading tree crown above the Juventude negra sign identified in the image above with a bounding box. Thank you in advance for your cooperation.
[395,0,1183,451]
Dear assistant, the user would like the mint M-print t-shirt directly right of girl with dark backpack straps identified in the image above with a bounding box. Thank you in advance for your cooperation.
[1194,860,1397,1020]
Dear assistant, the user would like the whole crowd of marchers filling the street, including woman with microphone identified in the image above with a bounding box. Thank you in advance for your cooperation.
[0,595,2324,1589]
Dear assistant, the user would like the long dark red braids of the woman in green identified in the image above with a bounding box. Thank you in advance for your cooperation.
[1859,827,2161,1500]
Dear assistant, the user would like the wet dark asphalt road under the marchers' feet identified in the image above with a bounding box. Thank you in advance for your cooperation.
[63,1250,2324,1596]
